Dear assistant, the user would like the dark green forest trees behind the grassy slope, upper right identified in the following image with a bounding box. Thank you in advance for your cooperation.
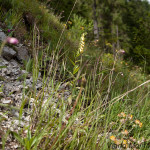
[45,0,150,73]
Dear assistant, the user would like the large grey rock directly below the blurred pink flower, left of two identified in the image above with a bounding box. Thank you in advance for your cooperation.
[2,46,17,61]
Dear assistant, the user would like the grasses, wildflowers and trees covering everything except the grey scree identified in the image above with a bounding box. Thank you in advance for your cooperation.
[0,0,150,150]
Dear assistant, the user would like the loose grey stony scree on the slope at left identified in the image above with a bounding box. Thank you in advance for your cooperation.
[0,25,69,150]
